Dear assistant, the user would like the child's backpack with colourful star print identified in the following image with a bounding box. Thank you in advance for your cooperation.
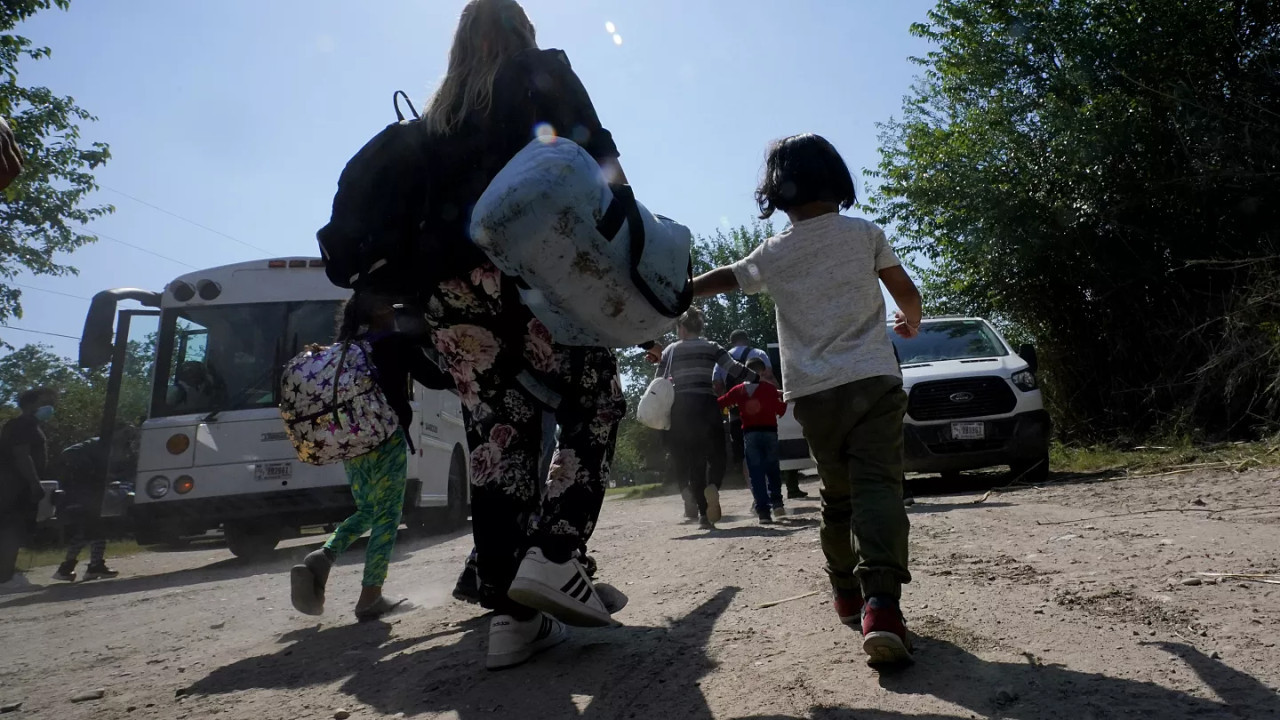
[280,340,399,465]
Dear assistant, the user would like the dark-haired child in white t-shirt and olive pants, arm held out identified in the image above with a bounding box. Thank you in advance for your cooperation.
[694,135,920,665]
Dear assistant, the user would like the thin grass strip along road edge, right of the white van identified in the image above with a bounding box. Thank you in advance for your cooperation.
[1050,442,1280,475]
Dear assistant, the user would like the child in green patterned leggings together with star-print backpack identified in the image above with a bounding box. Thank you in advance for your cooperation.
[280,291,439,621]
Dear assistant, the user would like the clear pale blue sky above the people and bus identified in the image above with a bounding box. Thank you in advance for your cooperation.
[3,0,933,356]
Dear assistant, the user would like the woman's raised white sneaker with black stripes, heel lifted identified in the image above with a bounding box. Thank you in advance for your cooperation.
[507,547,621,628]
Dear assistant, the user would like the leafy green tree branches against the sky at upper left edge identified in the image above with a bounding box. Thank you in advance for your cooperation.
[0,0,114,323]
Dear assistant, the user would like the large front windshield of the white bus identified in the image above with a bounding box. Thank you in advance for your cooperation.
[151,301,342,418]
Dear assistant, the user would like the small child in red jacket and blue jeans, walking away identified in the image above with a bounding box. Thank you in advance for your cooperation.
[719,359,787,524]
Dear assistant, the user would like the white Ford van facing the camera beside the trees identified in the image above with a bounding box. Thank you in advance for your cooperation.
[769,318,1051,482]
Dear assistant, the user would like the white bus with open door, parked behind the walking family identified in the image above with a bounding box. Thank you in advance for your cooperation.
[79,258,470,557]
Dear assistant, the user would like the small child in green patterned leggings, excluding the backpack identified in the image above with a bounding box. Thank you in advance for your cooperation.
[289,291,440,620]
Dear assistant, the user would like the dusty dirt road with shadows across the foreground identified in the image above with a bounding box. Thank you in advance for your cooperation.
[0,471,1280,720]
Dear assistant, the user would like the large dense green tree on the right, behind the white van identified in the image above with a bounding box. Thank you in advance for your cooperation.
[870,0,1280,438]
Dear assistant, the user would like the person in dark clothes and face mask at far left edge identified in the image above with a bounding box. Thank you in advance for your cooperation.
[0,388,58,583]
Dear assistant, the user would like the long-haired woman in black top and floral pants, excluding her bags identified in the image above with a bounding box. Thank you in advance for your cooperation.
[424,0,626,669]
